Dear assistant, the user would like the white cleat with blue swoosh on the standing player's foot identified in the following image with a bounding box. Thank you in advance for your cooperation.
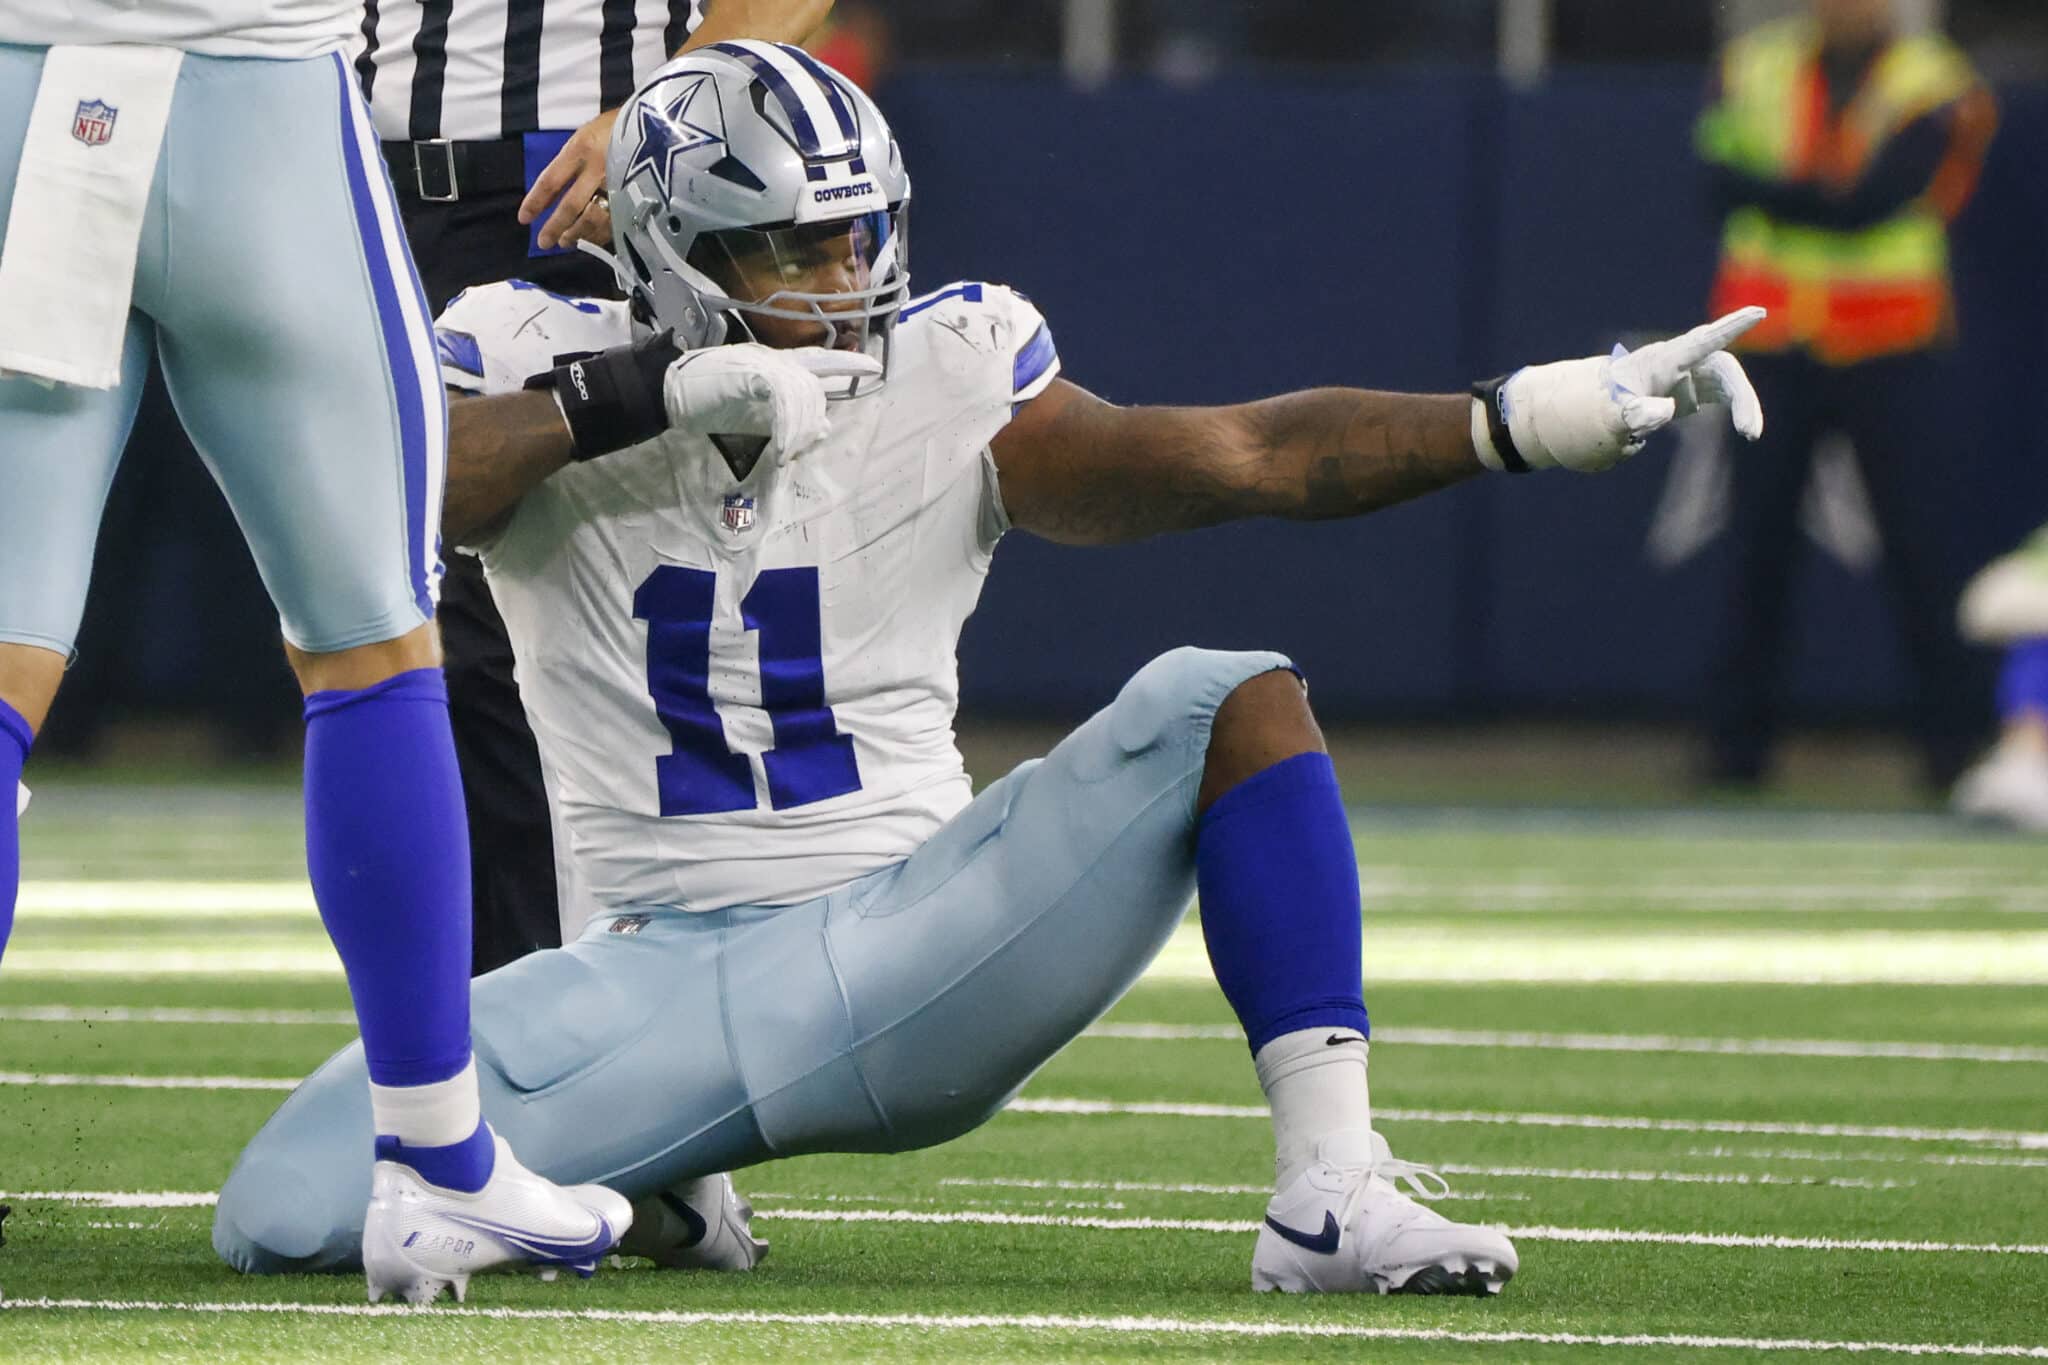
[362,1134,633,1304]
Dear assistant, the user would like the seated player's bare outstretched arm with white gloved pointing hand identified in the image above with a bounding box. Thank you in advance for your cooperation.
[991,309,1763,544]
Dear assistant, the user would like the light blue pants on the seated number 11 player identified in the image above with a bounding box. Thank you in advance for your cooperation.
[213,649,1290,1273]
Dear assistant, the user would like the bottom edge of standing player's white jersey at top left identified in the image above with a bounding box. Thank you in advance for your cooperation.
[0,0,362,57]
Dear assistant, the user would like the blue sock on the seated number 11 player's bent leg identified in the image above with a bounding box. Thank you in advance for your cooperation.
[1194,753,1370,1054]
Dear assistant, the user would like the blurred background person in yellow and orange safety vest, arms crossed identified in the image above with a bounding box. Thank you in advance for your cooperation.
[1698,0,1995,788]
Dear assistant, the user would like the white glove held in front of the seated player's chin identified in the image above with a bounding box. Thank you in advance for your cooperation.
[662,342,883,463]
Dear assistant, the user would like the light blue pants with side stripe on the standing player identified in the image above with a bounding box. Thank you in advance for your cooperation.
[0,45,446,655]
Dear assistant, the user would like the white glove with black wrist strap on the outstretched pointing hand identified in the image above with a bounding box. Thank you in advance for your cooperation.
[1473,307,1763,473]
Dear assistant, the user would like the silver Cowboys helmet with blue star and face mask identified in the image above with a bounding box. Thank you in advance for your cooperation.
[606,39,909,397]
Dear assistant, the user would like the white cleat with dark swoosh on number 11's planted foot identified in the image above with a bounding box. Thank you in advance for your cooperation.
[1251,1130,1520,1295]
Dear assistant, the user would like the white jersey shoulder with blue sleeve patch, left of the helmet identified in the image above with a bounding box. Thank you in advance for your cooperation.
[434,280,633,393]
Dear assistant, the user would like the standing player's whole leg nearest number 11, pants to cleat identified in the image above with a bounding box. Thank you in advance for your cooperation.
[158,55,627,1297]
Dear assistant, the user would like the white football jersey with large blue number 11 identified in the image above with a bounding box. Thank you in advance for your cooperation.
[442,284,1059,911]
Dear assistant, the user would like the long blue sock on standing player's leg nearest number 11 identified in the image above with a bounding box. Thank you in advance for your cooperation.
[305,669,492,1189]
